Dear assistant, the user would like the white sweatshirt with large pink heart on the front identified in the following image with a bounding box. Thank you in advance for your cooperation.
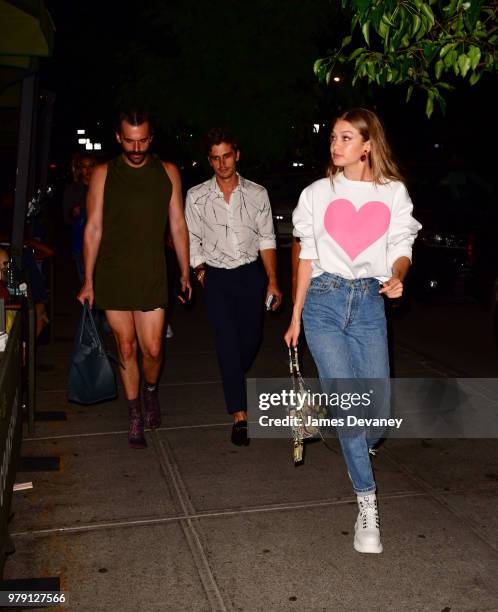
[292,172,422,281]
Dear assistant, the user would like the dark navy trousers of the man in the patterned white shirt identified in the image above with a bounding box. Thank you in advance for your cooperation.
[204,262,266,414]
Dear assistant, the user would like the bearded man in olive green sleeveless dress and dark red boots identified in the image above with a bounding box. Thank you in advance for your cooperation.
[78,110,191,448]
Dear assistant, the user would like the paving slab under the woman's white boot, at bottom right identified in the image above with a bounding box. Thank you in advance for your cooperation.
[195,497,498,612]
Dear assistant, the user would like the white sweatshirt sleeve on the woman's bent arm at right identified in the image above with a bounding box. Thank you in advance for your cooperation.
[387,184,422,269]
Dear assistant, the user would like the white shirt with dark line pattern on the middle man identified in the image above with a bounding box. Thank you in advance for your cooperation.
[185,175,276,268]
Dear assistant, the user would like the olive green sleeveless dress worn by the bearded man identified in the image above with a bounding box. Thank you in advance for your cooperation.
[95,155,173,310]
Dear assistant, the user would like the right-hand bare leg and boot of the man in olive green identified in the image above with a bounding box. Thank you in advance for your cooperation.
[133,309,165,429]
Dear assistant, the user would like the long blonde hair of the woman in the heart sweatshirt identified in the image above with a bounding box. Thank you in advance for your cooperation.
[327,108,404,184]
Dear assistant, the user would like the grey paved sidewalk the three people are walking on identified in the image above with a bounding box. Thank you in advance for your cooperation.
[4,262,498,612]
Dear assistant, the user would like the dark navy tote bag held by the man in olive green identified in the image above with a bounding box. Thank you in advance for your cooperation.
[67,300,117,404]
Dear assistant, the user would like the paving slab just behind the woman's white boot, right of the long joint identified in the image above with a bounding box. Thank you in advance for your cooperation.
[158,427,419,511]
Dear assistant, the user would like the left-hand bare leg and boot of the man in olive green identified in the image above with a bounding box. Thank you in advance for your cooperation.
[105,310,147,448]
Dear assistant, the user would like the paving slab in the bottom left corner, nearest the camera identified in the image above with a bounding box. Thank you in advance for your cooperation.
[4,524,210,612]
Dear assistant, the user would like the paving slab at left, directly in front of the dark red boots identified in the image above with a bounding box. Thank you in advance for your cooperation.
[10,435,176,533]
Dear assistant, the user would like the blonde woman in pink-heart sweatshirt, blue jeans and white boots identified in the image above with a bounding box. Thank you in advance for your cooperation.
[285,108,421,553]
